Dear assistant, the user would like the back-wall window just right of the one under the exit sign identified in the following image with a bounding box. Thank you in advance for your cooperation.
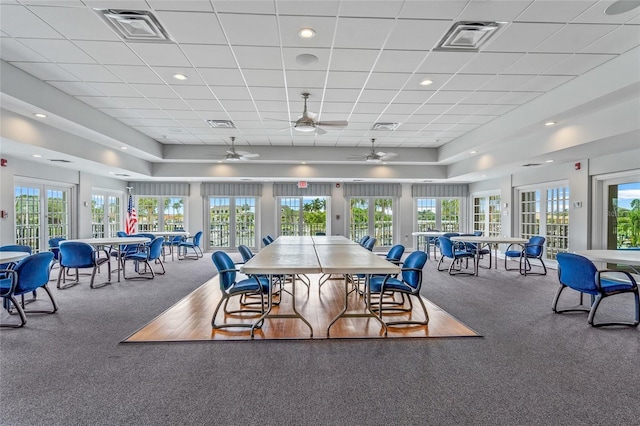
[349,198,393,247]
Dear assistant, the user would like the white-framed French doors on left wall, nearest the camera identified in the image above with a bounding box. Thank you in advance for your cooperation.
[14,181,72,253]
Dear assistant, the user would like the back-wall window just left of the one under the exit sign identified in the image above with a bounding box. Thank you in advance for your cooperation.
[209,197,257,248]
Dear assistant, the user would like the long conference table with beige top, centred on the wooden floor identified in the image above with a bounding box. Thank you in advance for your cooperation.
[240,236,400,338]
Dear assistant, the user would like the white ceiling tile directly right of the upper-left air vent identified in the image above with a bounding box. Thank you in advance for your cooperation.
[155,11,226,44]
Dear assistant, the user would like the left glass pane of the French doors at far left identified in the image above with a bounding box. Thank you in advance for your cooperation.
[14,186,40,252]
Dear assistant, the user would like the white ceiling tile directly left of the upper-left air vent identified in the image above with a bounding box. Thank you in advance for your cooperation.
[30,6,119,41]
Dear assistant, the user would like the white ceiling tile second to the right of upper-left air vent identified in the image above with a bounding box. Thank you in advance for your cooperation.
[218,10,280,46]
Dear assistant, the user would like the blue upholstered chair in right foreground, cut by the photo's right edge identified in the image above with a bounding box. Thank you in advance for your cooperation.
[552,253,640,327]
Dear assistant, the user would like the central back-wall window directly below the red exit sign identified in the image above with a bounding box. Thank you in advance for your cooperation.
[279,197,328,235]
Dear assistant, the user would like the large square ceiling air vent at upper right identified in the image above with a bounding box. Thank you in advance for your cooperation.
[434,21,504,52]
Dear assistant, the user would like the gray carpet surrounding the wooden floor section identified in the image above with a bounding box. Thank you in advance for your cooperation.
[0,254,640,425]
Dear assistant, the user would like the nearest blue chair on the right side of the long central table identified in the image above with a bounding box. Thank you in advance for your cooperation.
[368,251,429,336]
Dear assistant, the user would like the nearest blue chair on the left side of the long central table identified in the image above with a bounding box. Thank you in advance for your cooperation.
[211,251,269,329]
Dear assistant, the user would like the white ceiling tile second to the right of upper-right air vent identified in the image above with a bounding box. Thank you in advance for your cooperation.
[533,24,616,52]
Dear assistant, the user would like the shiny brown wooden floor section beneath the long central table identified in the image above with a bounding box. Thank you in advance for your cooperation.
[123,275,479,343]
